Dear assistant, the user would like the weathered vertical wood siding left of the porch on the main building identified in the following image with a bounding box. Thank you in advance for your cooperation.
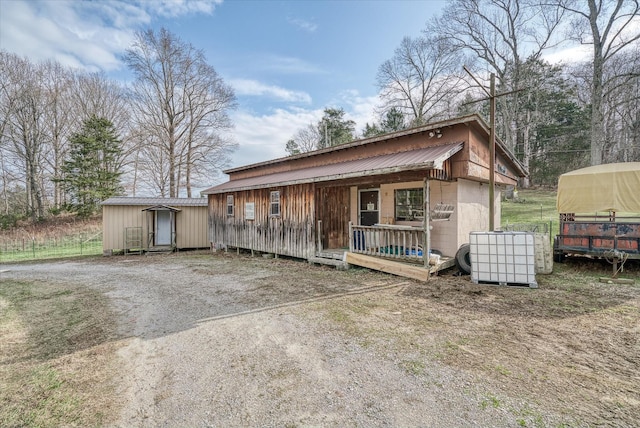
[209,184,315,259]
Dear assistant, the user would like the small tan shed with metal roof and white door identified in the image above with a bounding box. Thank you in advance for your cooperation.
[102,197,209,255]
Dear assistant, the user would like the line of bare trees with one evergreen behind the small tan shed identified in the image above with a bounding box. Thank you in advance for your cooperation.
[0,29,236,223]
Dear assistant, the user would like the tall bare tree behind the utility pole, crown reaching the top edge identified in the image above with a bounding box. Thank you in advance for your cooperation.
[427,0,562,149]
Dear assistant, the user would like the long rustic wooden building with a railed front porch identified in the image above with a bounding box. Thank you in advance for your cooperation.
[202,115,526,280]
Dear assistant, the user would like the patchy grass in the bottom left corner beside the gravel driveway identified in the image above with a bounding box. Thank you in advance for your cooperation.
[0,280,117,427]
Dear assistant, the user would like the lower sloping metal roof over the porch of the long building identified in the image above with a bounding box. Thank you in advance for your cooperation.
[201,142,464,195]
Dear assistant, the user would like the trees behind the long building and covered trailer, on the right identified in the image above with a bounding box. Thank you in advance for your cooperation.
[287,0,640,186]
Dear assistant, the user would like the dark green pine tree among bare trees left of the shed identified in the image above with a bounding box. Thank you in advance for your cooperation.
[61,116,122,217]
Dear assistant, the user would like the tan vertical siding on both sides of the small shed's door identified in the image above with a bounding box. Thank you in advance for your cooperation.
[102,205,209,251]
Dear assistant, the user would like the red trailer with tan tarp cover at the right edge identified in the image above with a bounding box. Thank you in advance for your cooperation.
[553,162,640,263]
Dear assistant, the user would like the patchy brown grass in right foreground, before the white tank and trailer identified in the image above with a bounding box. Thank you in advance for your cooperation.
[318,259,640,427]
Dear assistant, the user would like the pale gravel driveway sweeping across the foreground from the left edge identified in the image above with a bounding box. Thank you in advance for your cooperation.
[4,253,616,427]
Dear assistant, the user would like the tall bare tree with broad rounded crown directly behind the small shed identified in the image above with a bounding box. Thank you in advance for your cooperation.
[125,29,235,197]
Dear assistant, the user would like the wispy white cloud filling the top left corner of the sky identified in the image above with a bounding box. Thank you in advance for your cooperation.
[0,0,220,71]
